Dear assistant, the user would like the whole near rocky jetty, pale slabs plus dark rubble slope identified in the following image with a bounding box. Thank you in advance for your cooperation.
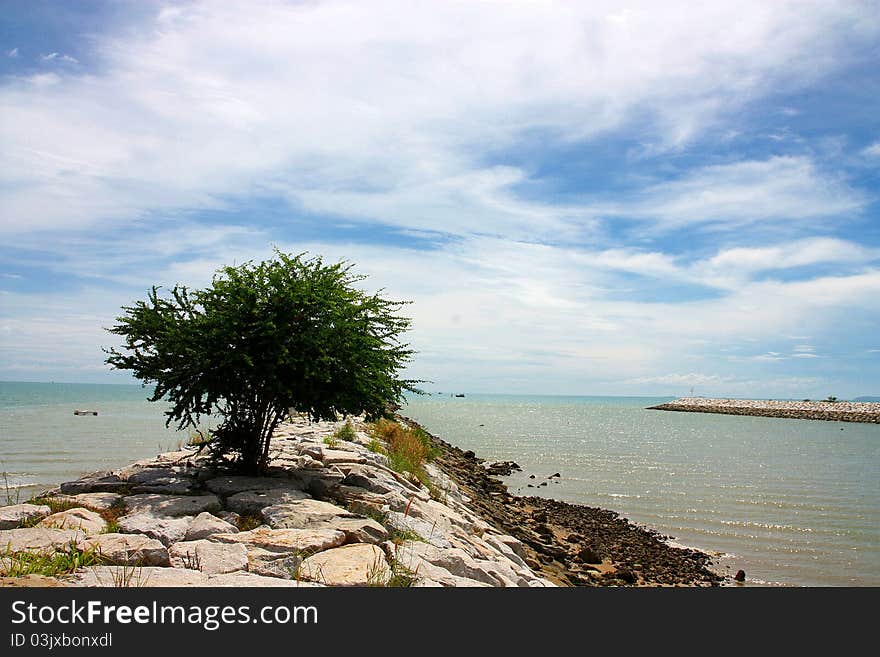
[0,418,723,587]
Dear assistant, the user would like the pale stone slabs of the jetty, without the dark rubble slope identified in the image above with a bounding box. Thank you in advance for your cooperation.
[0,419,554,587]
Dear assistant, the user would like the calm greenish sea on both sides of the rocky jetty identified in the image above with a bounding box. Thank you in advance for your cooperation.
[0,382,880,586]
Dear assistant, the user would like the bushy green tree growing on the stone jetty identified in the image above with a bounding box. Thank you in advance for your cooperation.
[105,249,420,473]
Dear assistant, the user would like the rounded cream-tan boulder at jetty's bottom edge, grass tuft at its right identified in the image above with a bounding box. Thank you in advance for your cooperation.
[299,544,391,586]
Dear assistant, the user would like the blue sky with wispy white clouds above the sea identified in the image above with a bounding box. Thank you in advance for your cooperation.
[0,0,880,399]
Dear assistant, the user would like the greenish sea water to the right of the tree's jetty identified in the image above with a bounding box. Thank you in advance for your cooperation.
[401,394,880,586]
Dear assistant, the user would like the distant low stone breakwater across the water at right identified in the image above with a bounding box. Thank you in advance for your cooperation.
[648,397,880,424]
